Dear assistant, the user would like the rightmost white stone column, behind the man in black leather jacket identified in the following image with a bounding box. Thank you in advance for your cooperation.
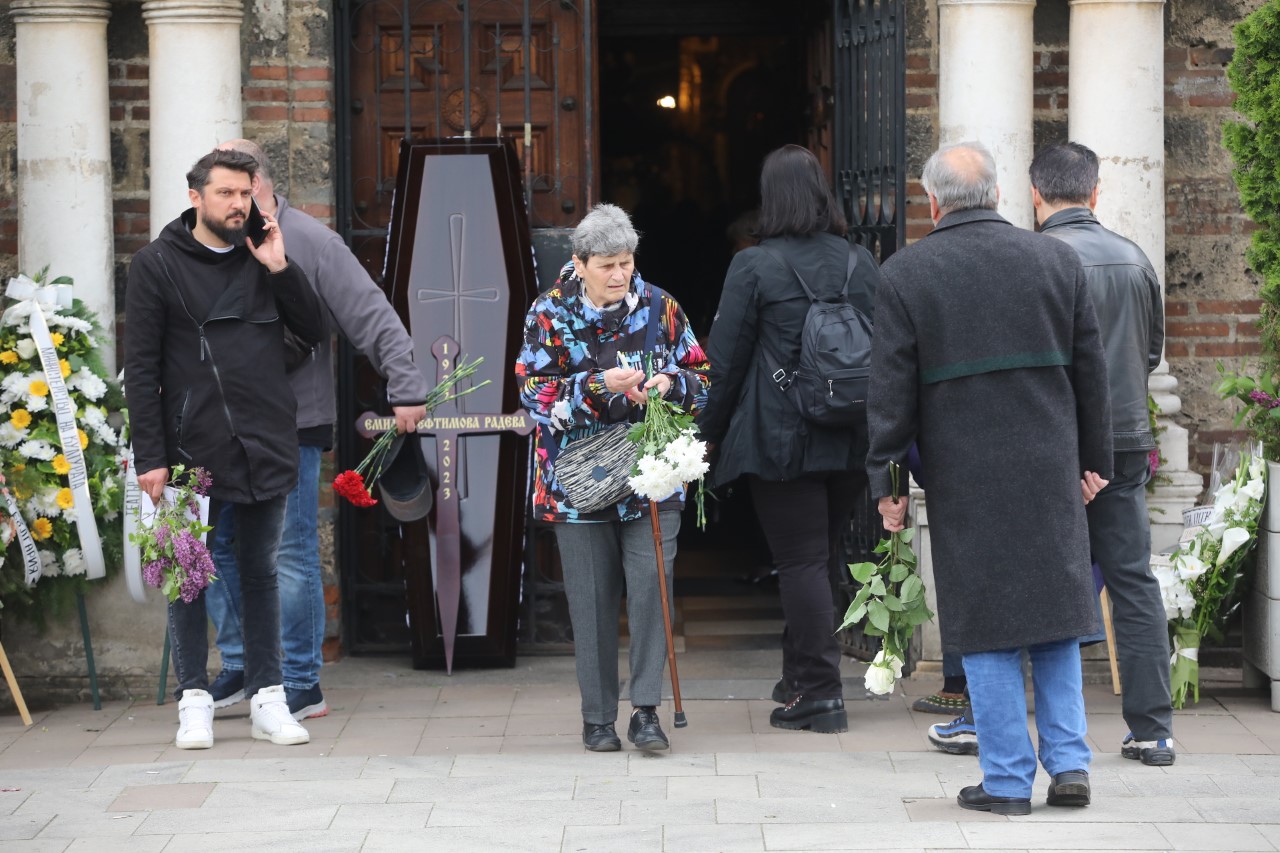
[1068,0,1202,551]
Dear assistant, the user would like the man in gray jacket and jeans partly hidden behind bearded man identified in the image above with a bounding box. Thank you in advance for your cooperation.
[206,140,428,720]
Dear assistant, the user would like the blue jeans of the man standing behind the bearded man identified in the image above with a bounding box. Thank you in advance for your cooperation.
[207,446,325,690]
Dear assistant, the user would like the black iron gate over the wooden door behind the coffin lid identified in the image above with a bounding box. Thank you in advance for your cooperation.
[334,0,596,652]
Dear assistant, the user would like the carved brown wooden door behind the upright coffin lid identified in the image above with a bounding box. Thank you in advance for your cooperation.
[344,0,596,270]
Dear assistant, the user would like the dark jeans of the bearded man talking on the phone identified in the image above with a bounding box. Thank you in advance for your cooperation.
[169,496,285,699]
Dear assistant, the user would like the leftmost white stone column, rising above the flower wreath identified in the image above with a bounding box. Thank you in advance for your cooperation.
[9,0,115,361]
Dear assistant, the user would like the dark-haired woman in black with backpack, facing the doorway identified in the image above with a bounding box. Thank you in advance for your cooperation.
[698,145,879,733]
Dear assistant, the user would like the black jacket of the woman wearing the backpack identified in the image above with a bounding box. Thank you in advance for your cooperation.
[698,233,879,485]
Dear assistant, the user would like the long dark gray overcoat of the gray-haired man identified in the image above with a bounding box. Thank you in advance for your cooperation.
[867,210,1112,653]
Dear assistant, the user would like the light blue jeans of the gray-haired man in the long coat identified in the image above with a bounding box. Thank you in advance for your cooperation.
[964,639,1093,797]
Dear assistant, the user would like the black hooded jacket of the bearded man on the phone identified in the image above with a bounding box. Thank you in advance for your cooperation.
[124,209,325,503]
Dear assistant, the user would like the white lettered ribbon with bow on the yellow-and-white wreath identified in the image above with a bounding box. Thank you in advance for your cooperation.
[5,275,106,583]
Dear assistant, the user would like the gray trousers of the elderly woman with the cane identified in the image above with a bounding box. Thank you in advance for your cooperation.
[556,510,680,725]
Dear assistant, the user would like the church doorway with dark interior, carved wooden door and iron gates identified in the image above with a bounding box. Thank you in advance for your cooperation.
[335,0,905,652]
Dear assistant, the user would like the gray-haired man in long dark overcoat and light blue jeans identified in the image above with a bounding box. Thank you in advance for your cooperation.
[867,142,1111,815]
